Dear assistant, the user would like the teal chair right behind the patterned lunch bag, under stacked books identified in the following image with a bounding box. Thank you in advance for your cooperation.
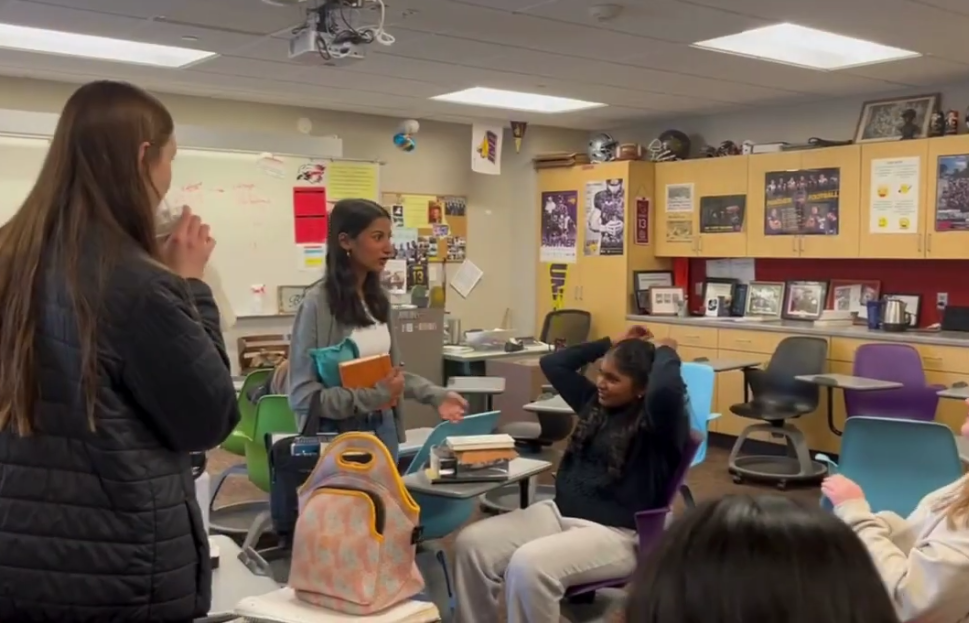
[404,411,501,608]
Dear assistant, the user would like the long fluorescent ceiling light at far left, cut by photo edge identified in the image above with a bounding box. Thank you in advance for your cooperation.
[0,24,218,68]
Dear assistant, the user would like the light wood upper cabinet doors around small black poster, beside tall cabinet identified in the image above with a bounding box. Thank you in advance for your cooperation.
[655,161,749,257]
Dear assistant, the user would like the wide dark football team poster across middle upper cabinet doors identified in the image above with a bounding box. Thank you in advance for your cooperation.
[764,168,841,236]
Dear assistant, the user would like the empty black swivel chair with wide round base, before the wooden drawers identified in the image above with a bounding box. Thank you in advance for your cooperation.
[728,337,828,489]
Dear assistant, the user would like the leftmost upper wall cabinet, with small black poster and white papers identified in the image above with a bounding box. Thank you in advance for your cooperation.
[655,156,750,257]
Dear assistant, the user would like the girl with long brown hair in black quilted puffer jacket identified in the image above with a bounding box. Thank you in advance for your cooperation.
[0,82,239,623]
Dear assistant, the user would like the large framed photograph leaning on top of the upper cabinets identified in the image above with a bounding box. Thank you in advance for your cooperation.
[855,93,940,143]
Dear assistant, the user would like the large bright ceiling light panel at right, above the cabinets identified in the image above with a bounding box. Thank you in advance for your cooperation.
[693,24,922,70]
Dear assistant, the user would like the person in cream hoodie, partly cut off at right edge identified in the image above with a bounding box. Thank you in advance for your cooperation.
[821,401,969,623]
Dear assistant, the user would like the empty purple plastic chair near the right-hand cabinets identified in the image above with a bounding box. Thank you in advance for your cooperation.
[844,344,945,422]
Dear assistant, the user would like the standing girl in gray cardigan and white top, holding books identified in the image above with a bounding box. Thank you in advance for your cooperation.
[289,199,468,457]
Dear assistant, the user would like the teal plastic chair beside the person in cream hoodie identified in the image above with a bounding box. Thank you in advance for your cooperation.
[816,415,963,517]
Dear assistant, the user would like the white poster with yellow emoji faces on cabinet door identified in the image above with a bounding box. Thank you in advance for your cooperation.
[868,156,921,234]
